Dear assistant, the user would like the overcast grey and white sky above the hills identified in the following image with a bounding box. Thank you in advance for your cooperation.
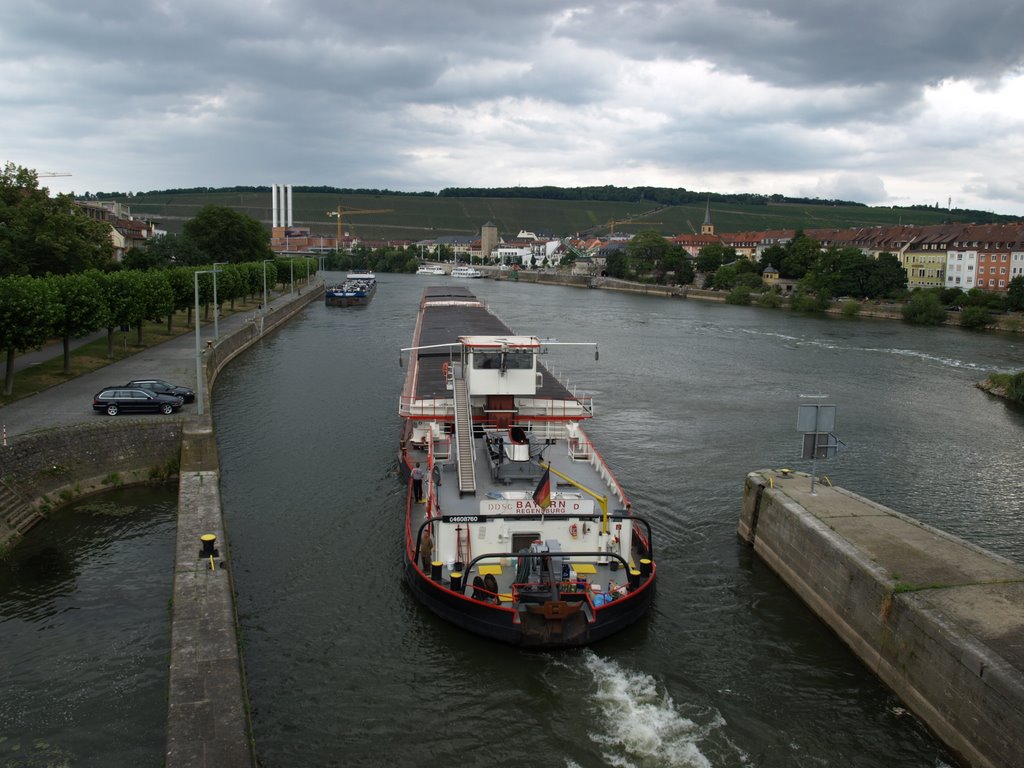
[0,0,1024,215]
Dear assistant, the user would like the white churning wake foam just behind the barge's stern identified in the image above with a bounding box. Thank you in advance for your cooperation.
[583,651,725,768]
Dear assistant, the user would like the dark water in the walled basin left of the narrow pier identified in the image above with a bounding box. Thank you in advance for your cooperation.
[0,486,177,768]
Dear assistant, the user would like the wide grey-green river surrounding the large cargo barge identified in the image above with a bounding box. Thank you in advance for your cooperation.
[0,275,1024,768]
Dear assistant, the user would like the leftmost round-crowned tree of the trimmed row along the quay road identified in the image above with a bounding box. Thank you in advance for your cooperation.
[0,274,60,394]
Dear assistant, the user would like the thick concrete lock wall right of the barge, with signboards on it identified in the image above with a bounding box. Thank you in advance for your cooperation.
[738,470,1024,768]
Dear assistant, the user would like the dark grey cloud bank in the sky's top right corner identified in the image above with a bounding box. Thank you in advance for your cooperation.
[566,0,1024,87]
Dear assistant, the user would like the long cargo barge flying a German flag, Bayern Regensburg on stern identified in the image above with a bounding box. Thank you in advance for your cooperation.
[399,287,656,648]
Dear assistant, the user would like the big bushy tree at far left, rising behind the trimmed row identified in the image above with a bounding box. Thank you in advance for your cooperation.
[0,163,114,276]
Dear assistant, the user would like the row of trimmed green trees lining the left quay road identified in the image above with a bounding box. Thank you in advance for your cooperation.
[0,259,316,395]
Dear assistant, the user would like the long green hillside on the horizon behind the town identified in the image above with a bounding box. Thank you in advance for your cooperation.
[110,189,1007,241]
